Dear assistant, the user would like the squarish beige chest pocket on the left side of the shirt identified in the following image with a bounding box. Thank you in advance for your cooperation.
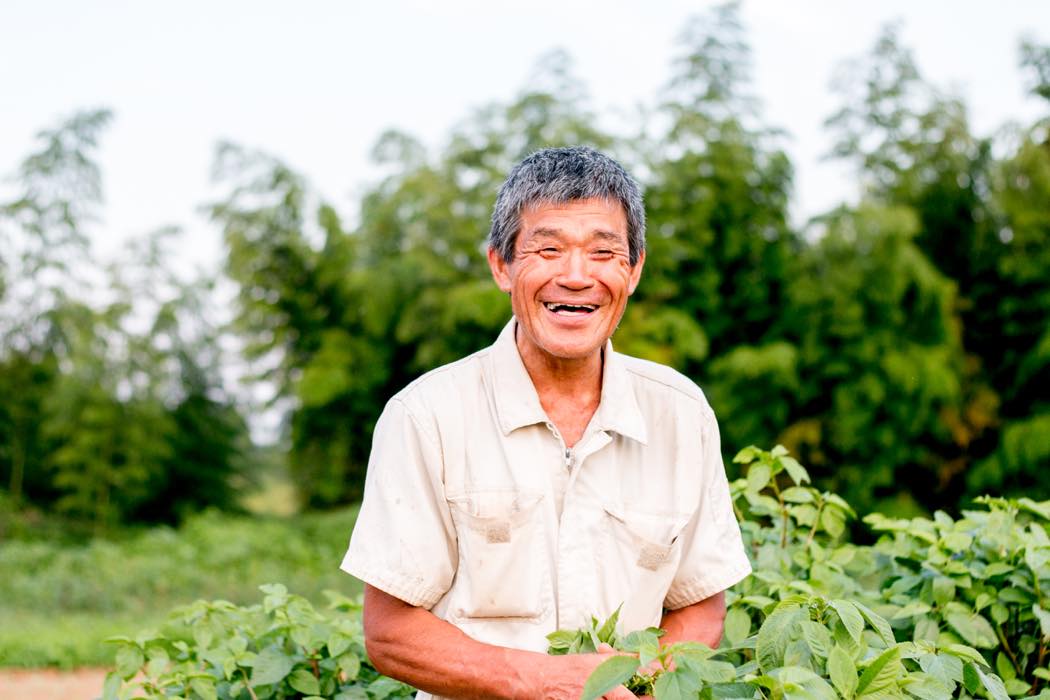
[448,491,548,619]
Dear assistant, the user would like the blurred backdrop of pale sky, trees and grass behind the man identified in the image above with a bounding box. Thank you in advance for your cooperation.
[0,0,1050,667]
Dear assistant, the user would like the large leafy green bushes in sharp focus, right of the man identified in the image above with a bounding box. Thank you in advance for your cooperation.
[548,447,1050,700]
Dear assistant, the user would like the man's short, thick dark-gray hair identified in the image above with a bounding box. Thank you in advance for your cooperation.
[488,146,646,266]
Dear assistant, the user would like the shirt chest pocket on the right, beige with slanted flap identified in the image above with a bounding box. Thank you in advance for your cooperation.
[595,504,689,633]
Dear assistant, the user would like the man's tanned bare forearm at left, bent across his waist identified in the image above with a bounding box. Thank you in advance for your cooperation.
[364,585,634,700]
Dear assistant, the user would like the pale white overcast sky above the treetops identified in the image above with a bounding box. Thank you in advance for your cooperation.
[0,0,1050,270]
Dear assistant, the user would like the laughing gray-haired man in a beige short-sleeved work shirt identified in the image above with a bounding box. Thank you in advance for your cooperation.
[342,148,751,698]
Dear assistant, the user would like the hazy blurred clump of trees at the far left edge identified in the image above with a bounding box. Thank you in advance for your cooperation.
[0,116,248,532]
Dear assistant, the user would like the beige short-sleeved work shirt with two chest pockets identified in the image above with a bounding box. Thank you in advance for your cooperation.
[342,319,751,698]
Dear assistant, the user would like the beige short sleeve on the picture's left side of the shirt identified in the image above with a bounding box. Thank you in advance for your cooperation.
[340,398,458,609]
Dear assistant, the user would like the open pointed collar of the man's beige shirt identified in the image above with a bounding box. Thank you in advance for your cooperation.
[491,318,647,445]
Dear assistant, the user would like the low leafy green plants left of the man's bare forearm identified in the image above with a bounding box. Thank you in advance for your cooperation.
[102,584,414,700]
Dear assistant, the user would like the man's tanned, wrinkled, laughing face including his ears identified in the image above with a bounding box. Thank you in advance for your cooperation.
[488,194,645,362]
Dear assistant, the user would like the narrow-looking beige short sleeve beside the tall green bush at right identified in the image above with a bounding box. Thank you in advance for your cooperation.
[664,406,751,610]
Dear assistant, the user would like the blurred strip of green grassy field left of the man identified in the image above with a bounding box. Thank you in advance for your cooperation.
[0,508,360,669]
